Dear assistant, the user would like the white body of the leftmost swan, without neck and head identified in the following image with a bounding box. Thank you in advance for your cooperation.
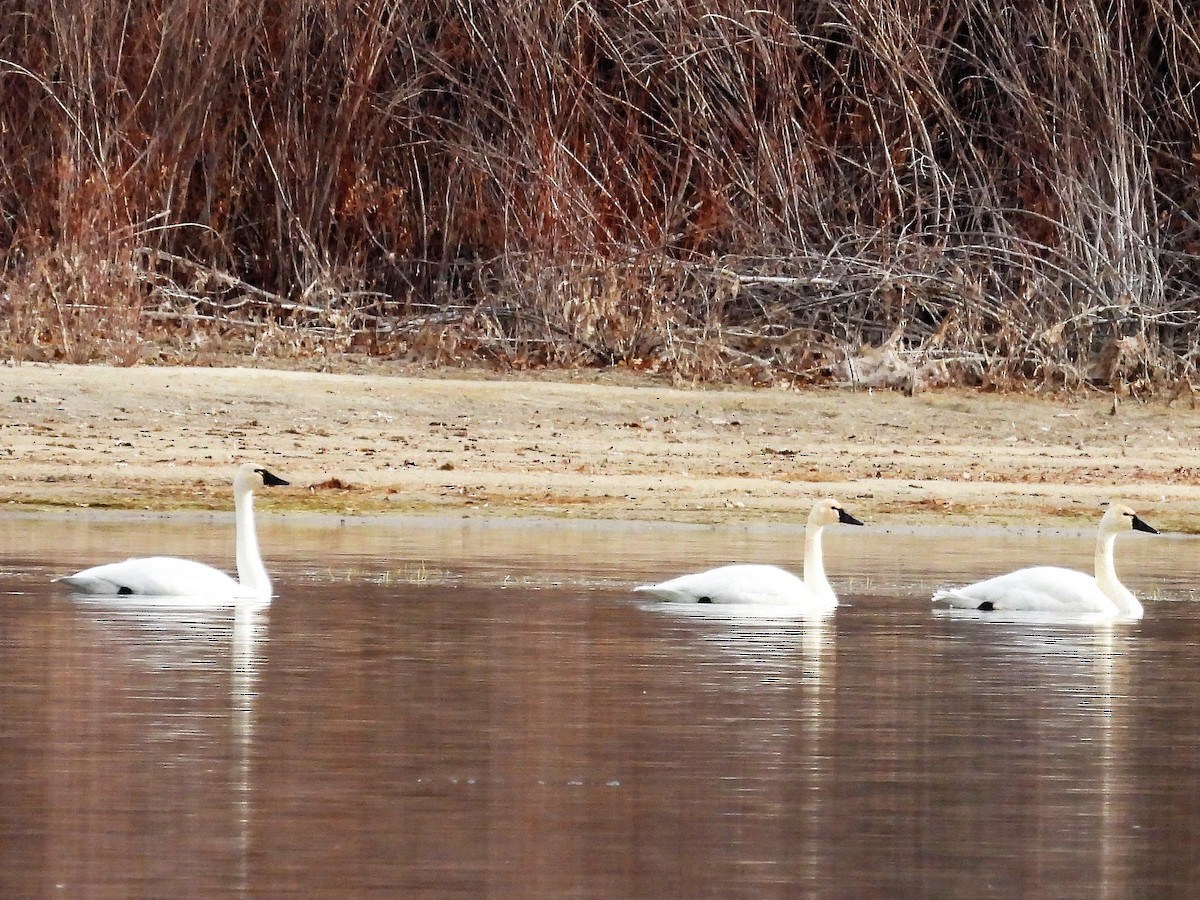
[58,557,246,598]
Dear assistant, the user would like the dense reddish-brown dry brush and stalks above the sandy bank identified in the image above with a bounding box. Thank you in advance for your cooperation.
[0,0,1200,390]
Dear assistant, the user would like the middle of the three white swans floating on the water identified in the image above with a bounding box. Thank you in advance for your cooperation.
[634,499,863,612]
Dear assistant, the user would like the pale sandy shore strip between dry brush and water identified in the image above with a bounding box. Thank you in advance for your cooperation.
[0,365,1200,532]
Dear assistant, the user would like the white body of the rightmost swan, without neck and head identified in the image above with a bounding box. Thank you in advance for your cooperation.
[934,565,1116,612]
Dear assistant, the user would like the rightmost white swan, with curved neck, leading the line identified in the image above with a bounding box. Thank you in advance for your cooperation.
[934,503,1158,618]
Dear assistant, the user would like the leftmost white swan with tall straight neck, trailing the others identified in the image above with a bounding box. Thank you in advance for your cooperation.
[55,462,288,600]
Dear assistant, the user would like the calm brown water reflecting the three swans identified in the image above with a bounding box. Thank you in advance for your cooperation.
[0,515,1200,898]
